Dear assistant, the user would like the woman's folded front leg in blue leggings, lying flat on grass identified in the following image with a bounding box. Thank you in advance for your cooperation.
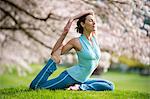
[79,79,114,91]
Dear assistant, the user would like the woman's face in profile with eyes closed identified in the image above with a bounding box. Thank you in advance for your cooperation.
[83,15,96,32]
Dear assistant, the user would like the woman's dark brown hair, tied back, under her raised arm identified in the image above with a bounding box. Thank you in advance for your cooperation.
[75,13,91,34]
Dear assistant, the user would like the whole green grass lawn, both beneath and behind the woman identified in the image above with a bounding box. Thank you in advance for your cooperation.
[0,65,150,99]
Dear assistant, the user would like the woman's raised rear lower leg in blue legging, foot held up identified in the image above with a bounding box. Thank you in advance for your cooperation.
[30,59,57,89]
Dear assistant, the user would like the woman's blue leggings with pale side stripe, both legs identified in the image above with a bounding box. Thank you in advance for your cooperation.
[30,59,114,91]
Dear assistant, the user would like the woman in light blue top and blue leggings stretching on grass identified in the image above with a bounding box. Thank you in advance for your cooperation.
[30,11,114,91]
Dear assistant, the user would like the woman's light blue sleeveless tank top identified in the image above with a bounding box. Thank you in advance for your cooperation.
[67,34,100,82]
